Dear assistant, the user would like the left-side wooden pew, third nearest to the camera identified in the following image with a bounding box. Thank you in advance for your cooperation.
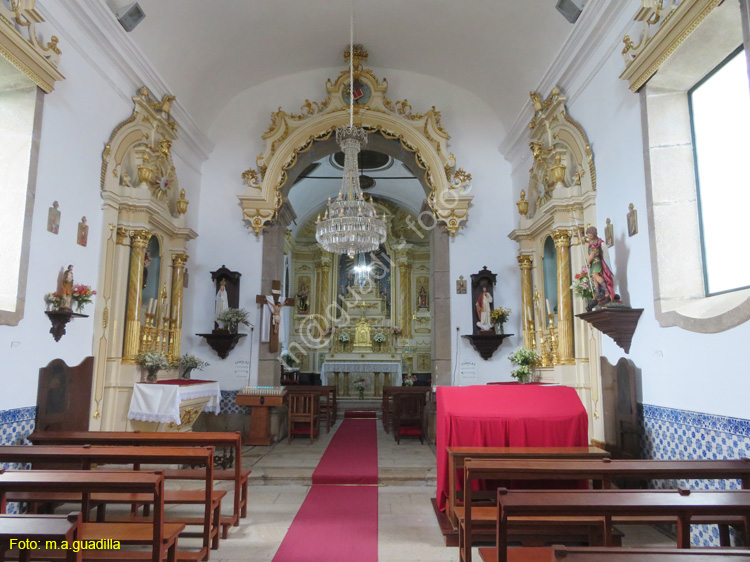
[0,445,220,559]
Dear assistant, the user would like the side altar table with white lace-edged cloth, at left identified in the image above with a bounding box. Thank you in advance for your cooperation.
[128,379,221,431]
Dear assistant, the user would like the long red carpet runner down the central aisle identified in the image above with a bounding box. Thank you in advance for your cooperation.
[273,419,378,562]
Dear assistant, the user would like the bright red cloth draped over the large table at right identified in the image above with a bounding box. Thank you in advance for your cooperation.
[436,384,589,510]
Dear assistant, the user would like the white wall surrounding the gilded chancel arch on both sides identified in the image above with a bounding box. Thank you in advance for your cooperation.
[184,68,521,389]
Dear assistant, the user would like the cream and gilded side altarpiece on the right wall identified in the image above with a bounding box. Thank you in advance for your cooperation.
[509,88,604,442]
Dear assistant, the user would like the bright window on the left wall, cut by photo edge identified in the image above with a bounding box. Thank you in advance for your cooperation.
[0,56,37,324]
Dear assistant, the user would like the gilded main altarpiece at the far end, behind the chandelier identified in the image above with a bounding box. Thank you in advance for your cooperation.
[289,199,433,396]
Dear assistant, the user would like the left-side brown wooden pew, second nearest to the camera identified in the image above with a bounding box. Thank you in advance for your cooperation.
[0,470,184,562]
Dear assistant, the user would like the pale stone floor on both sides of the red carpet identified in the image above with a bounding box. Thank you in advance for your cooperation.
[164,420,670,562]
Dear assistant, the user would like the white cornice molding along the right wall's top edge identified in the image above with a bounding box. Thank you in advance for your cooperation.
[499,0,641,169]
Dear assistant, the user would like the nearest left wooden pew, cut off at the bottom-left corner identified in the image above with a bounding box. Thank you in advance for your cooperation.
[0,513,82,562]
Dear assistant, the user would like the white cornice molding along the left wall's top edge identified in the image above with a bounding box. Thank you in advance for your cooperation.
[38,0,214,164]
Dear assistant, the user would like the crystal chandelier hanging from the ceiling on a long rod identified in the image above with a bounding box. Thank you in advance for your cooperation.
[315,3,386,258]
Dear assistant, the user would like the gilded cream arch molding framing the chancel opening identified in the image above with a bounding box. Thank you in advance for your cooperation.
[239,45,473,236]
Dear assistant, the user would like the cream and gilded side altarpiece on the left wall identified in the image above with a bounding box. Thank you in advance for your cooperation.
[91,87,197,430]
